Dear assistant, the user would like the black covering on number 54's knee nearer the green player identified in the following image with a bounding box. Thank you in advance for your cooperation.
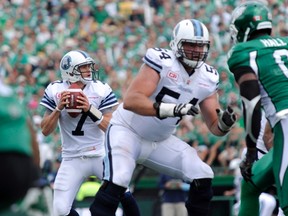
[186,178,213,216]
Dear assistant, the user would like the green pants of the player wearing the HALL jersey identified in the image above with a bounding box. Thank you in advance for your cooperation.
[239,119,288,216]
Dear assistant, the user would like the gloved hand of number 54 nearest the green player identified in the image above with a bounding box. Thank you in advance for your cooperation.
[216,106,236,133]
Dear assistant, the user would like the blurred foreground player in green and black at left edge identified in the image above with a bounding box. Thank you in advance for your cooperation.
[0,79,40,211]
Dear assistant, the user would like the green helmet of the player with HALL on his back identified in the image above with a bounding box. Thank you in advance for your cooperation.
[230,1,272,43]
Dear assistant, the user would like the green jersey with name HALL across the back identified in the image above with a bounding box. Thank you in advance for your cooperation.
[228,35,288,126]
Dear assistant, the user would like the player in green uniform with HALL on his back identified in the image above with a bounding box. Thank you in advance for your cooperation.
[228,1,288,216]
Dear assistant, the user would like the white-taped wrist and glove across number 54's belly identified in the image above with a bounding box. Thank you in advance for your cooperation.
[153,102,199,118]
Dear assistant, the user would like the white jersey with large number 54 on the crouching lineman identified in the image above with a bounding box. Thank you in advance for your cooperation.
[111,48,219,141]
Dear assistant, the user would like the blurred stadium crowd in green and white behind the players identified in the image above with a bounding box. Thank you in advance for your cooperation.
[0,0,288,175]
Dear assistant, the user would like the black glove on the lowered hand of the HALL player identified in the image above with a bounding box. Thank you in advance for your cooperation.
[240,148,257,182]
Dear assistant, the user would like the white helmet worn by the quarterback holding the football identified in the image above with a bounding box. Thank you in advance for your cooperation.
[60,50,95,84]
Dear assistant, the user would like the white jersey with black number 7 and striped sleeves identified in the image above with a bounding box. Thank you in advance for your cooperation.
[40,80,118,158]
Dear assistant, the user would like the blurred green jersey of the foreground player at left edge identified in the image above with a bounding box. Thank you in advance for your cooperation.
[0,83,32,156]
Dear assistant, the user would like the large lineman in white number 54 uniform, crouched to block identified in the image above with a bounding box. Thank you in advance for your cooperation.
[90,19,236,216]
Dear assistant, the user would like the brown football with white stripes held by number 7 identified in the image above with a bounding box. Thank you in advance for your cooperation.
[65,83,82,118]
